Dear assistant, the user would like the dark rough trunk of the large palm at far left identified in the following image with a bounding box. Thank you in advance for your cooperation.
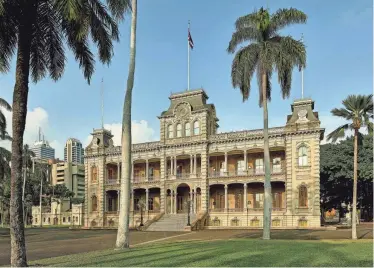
[10,21,33,267]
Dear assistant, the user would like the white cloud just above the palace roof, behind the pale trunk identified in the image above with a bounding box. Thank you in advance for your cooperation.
[84,120,157,147]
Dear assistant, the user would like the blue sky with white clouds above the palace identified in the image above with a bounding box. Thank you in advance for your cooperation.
[0,0,373,158]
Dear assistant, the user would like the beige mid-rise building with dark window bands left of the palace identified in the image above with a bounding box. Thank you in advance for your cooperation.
[52,162,84,198]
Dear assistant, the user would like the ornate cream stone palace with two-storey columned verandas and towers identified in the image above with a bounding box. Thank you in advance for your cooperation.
[84,89,324,230]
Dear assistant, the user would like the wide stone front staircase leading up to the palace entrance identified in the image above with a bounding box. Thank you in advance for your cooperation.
[146,213,196,232]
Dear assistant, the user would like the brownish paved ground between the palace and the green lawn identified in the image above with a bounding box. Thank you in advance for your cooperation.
[0,224,373,265]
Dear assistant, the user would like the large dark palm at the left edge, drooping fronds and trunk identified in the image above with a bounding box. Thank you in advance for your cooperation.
[0,0,130,266]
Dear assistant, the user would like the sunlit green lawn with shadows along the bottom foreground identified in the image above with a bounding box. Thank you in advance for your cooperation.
[30,239,373,267]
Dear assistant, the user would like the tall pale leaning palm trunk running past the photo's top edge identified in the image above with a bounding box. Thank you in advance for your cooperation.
[116,0,137,249]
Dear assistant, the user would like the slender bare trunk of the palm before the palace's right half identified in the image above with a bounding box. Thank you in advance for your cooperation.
[261,72,272,239]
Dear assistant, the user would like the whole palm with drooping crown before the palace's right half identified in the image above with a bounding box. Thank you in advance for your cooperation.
[227,7,307,239]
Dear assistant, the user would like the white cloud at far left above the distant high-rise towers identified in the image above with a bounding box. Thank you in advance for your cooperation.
[0,107,64,157]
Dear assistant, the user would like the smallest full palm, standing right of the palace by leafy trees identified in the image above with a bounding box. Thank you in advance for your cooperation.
[327,94,373,239]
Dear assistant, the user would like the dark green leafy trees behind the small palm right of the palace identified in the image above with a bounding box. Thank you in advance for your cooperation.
[320,135,373,220]
